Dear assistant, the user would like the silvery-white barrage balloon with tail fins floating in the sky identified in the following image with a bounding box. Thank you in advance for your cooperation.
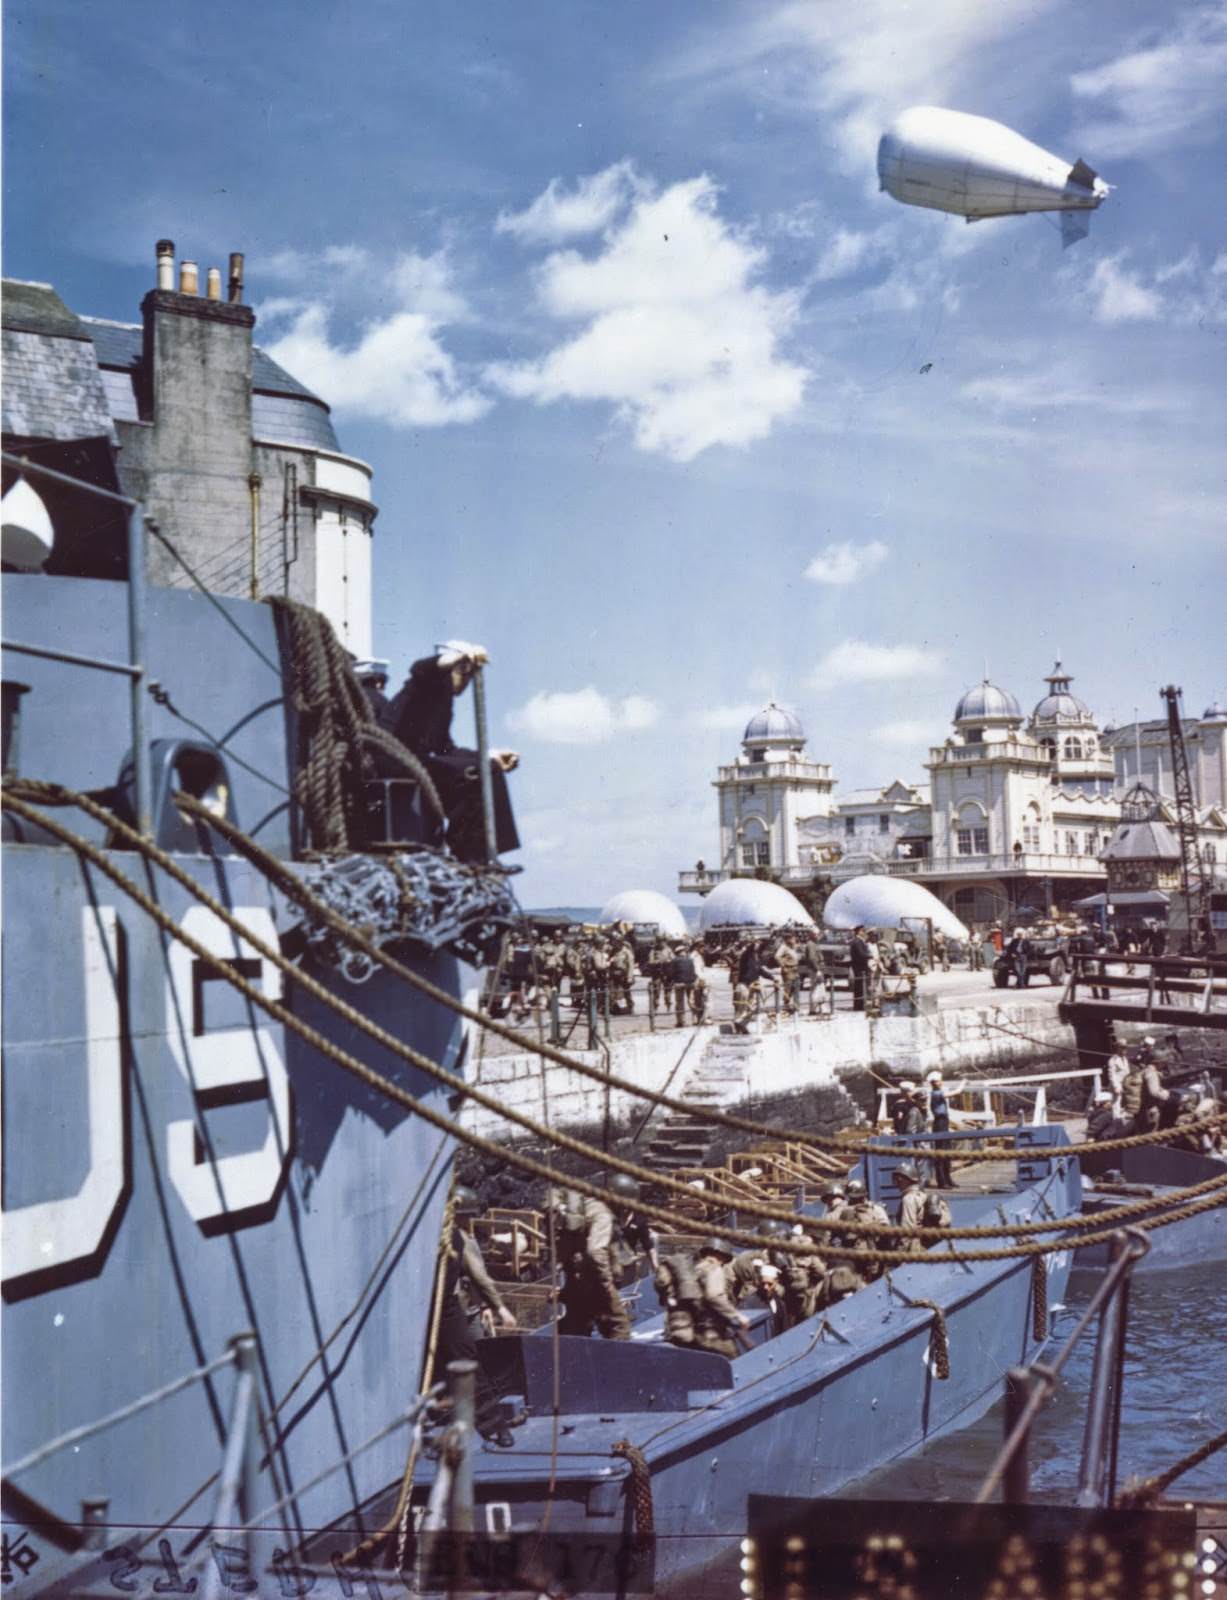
[878,106,1110,245]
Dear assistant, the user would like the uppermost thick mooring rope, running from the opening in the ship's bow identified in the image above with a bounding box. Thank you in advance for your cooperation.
[170,779,1227,1165]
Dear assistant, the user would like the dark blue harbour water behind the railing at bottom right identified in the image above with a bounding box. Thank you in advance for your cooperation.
[841,1266,1227,1504]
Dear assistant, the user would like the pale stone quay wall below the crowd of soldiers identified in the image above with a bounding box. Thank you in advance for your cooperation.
[459,1003,1073,1142]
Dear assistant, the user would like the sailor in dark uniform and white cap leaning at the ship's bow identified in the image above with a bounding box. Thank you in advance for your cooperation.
[390,638,520,861]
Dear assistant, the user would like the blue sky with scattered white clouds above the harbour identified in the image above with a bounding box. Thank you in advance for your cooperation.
[3,0,1227,906]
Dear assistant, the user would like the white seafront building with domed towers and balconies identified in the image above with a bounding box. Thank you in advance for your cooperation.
[678,661,1227,925]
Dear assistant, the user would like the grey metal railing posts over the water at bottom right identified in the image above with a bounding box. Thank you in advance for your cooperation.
[974,1227,1150,1507]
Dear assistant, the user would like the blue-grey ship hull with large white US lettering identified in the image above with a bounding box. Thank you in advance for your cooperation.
[3,578,464,1594]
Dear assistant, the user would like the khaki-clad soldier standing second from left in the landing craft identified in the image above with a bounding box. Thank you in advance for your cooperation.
[550,1173,659,1339]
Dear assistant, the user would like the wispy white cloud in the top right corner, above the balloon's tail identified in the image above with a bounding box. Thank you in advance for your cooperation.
[1070,3,1227,162]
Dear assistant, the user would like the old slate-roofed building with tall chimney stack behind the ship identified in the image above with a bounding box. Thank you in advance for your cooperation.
[3,240,376,656]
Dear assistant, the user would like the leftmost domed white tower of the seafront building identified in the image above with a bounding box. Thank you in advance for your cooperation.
[700,699,835,893]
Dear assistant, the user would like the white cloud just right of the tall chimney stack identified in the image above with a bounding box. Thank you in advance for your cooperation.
[261,245,493,427]
